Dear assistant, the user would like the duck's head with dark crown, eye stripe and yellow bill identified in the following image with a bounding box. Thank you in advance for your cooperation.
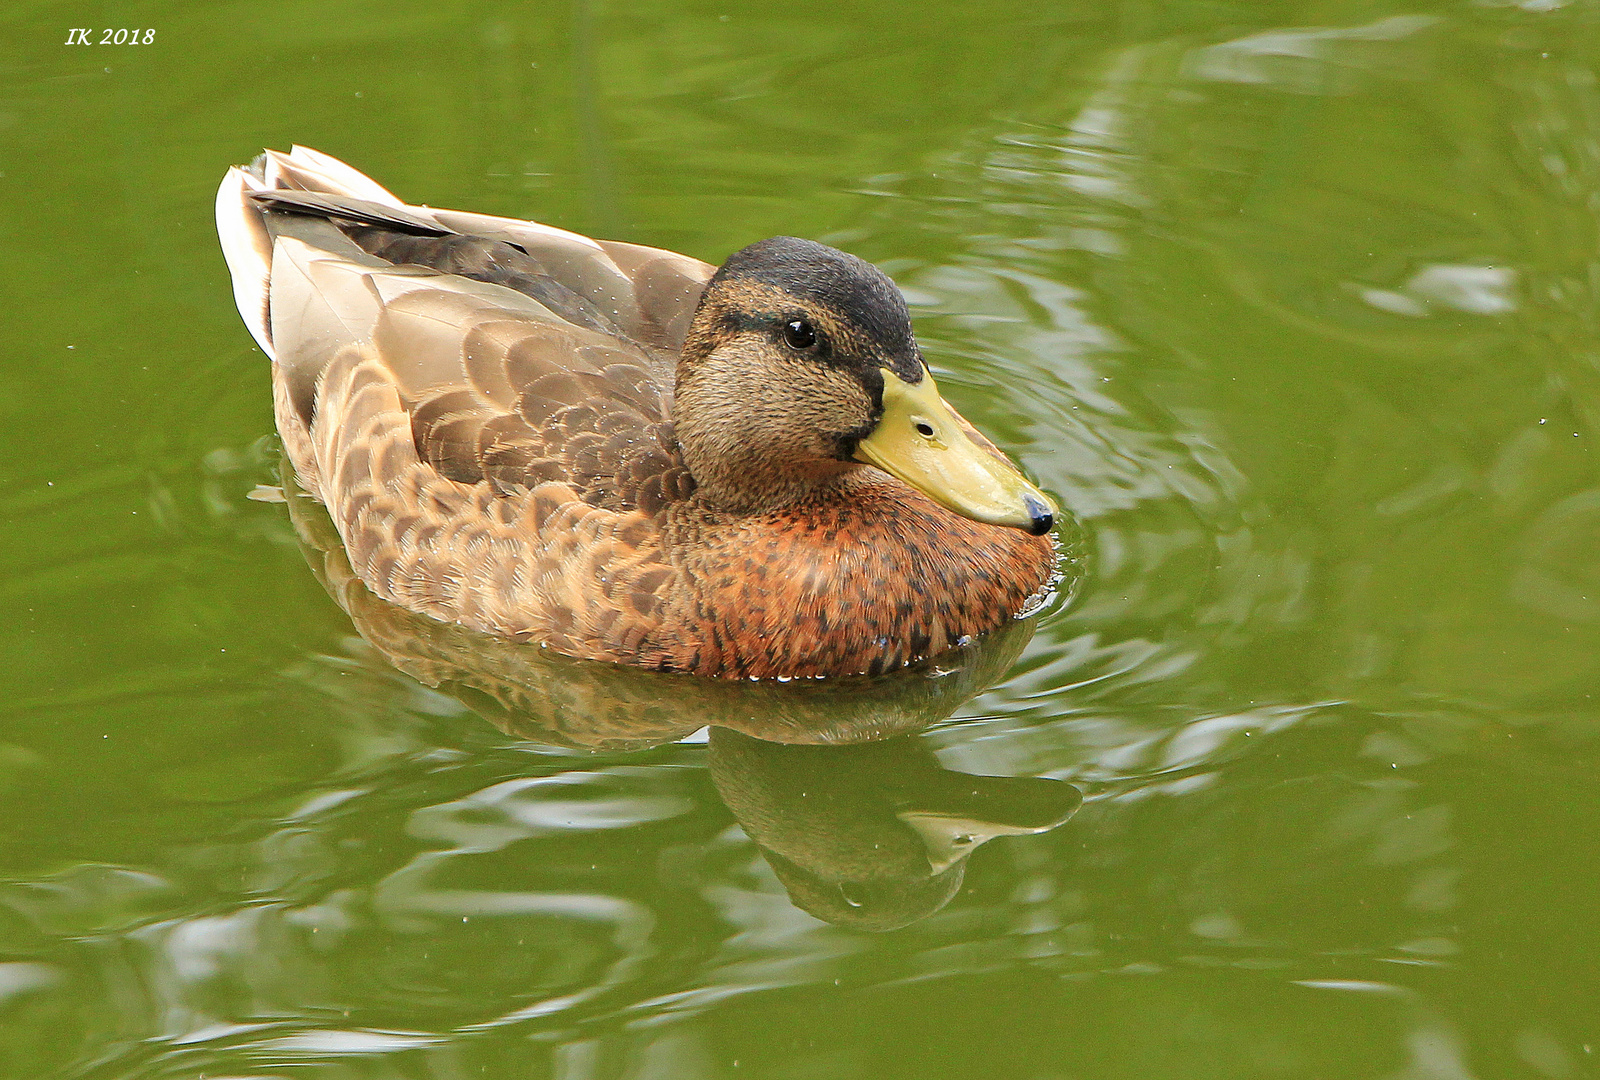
[674,237,1054,536]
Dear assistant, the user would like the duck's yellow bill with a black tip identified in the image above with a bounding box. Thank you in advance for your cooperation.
[856,368,1056,536]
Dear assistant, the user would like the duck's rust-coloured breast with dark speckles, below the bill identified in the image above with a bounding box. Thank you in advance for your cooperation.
[669,472,1056,678]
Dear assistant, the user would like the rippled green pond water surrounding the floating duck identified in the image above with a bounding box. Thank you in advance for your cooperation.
[0,0,1600,1080]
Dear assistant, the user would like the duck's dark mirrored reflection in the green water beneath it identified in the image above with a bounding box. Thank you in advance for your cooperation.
[283,469,1082,930]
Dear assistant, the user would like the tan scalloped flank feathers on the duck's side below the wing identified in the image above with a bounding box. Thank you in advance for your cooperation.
[278,337,698,669]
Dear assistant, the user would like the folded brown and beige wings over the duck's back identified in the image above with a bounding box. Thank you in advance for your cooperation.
[258,184,712,514]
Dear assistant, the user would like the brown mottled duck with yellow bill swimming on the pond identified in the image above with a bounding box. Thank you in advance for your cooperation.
[216,146,1058,680]
